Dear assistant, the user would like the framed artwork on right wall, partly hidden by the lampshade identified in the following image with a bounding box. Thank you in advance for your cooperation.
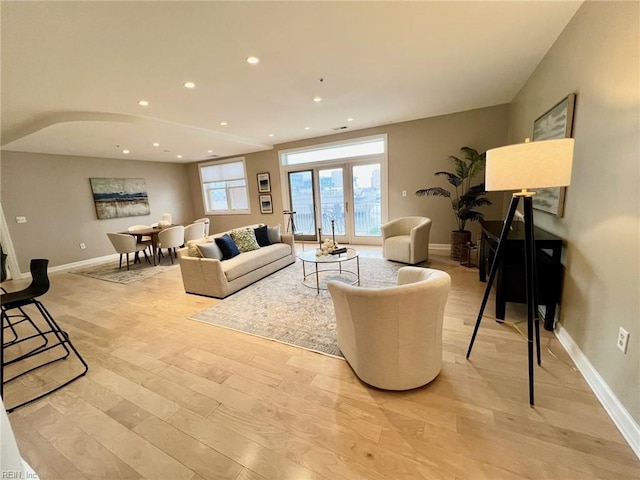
[533,93,576,217]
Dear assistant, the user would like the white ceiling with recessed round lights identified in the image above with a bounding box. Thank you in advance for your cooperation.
[0,1,582,162]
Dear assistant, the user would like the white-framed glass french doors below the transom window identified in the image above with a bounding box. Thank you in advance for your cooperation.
[288,161,383,244]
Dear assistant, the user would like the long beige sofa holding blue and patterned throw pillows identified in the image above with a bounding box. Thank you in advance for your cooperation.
[178,226,296,298]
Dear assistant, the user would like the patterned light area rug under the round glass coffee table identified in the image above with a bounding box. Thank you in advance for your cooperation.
[190,258,401,357]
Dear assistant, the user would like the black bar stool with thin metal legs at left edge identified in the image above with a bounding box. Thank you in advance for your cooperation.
[0,259,89,412]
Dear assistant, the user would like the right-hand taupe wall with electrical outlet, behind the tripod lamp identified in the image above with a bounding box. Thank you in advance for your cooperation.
[509,2,640,423]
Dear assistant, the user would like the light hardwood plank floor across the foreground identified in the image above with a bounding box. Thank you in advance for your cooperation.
[4,249,640,480]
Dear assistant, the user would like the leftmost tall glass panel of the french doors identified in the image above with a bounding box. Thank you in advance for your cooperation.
[287,170,317,240]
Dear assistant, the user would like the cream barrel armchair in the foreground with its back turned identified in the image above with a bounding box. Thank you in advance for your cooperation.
[328,267,451,390]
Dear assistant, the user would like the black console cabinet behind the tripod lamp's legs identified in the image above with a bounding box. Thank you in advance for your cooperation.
[478,221,563,330]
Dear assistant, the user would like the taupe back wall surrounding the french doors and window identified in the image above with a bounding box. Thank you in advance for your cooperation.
[189,105,508,240]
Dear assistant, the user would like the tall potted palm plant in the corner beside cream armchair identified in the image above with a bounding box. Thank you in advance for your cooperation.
[416,147,491,260]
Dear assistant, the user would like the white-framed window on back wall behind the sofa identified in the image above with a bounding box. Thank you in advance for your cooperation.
[199,157,251,215]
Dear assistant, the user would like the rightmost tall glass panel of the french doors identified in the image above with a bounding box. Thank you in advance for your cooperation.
[352,163,382,237]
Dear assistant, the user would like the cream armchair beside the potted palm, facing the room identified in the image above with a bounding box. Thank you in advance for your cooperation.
[382,217,431,265]
